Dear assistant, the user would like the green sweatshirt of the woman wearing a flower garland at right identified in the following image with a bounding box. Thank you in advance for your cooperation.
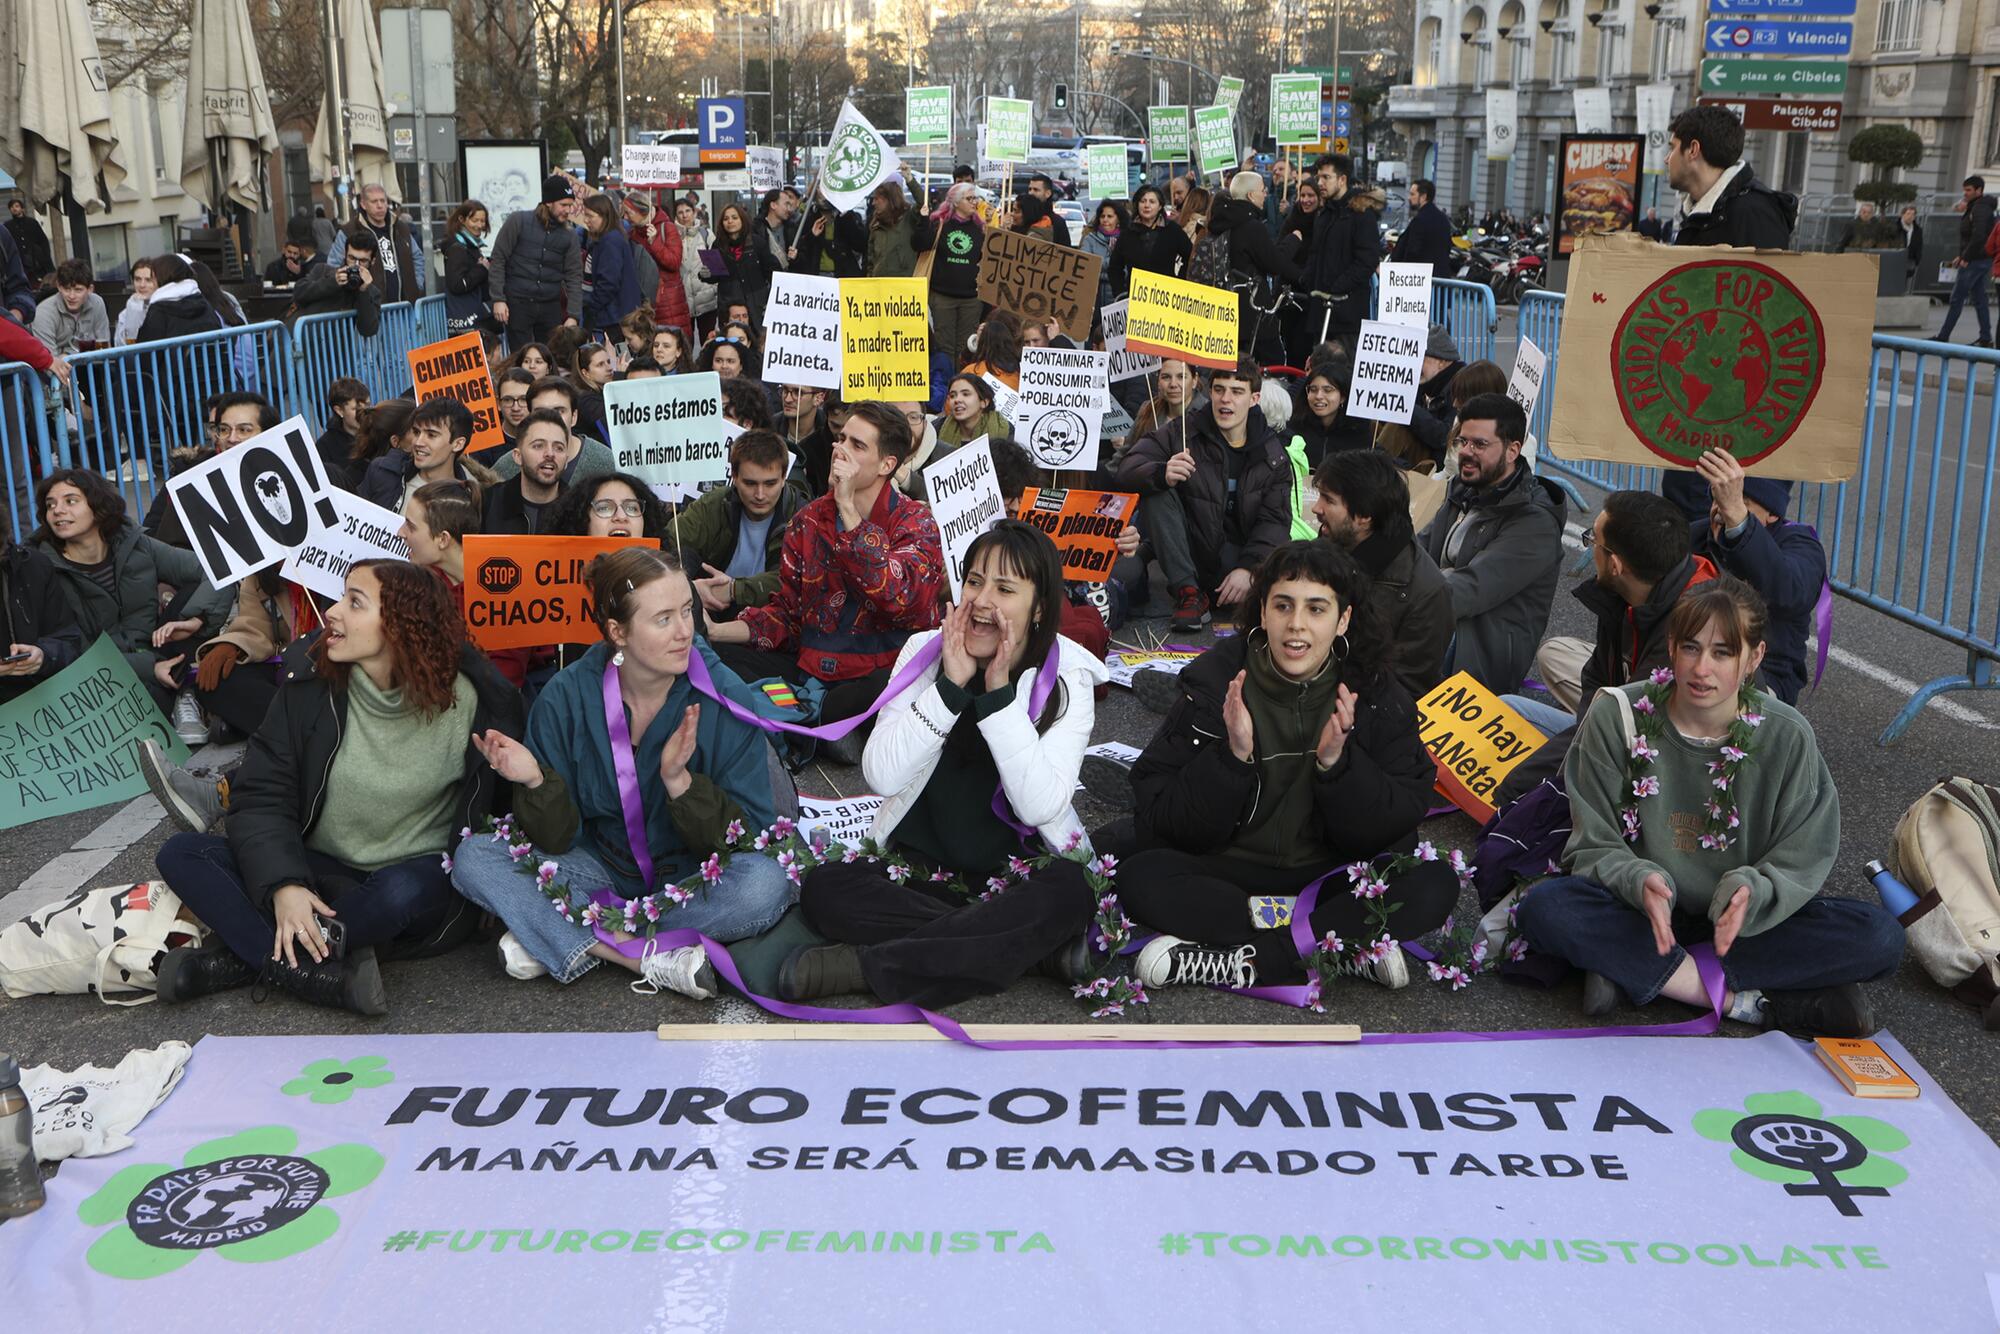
[1564,682,1840,936]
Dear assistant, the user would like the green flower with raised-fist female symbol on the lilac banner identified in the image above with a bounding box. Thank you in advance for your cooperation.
[1694,1090,1910,1218]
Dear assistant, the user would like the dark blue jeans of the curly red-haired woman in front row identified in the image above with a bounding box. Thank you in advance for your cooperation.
[154,834,472,966]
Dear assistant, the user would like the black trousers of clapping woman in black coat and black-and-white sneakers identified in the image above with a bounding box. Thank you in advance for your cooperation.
[1118,848,1458,986]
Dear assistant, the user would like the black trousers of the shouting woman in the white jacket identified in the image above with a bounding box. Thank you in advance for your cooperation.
[798,858,1096,1008]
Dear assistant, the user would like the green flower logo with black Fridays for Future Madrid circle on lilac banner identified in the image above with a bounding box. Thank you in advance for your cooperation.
[76,1126,384,1278]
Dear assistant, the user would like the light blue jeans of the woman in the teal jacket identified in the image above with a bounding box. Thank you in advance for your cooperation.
[452,834,798,982]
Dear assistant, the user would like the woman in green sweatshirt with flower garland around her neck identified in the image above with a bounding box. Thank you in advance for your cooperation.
[1516,576,1902,1038]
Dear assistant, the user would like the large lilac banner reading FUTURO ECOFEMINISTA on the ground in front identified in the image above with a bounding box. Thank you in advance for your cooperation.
[15,1032,2000,1334]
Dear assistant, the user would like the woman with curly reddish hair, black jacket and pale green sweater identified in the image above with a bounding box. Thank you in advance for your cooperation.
[158,560,522,1014]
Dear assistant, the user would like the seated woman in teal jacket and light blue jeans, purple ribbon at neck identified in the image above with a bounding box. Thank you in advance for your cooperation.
[452,546,796,1000]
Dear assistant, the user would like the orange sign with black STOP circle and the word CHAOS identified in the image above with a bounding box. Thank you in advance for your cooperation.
[464,536,652,648]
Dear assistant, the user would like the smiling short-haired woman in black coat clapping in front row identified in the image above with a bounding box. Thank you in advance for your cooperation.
[1118,542,1458,988]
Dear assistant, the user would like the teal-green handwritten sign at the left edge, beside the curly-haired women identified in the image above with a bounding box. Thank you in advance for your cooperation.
[0,636,191,830]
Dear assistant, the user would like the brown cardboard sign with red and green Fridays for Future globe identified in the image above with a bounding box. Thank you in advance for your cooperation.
[1548,236,1876,482]
